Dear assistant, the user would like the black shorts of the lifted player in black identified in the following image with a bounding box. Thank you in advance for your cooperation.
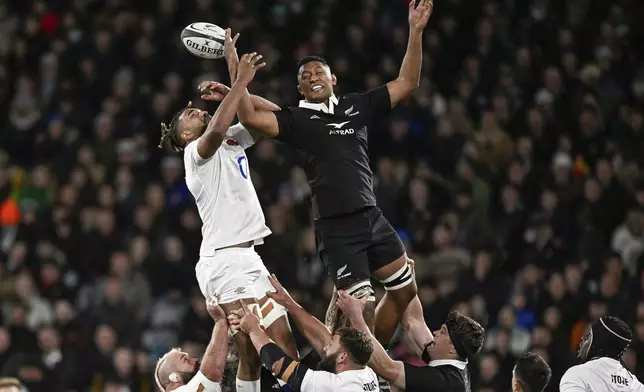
[315,207,405,289]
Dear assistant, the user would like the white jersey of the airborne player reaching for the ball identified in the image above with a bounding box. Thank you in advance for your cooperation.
[183,124,271,257]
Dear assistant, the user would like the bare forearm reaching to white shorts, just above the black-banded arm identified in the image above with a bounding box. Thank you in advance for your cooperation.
[266,275,332,357]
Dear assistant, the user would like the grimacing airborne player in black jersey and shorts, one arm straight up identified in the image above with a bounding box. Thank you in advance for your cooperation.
[231,0,433,350]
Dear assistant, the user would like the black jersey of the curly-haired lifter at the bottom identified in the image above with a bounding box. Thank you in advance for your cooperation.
[405,363,463,392]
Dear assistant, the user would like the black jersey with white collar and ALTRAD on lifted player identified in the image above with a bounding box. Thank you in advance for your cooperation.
[275,86,391,219]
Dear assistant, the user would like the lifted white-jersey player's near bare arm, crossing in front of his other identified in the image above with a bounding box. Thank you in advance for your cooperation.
[197,53,266,159]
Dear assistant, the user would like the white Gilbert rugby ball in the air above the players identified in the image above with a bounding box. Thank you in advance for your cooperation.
[181,22,226,60]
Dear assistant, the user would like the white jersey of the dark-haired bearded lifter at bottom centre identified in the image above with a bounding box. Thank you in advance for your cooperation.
[300,367,379,392]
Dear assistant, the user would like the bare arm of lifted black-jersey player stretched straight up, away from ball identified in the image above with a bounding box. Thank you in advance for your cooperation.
[387,0,434,107]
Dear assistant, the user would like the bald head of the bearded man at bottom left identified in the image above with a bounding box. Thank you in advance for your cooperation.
[154,348,199,391]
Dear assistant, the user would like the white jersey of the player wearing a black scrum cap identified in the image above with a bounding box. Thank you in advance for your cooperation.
[559,358,644,392]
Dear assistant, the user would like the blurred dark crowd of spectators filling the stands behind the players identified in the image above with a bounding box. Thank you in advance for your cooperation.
[0,0,644,392]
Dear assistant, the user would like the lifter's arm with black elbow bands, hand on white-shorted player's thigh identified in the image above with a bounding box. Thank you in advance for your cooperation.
[229,303,311,392]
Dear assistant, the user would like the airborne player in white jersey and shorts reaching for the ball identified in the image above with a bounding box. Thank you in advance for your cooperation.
[159,29,298,392]
